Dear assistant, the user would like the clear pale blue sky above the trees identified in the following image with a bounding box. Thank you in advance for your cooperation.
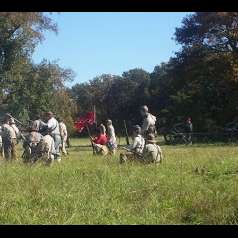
[33,12,192,86]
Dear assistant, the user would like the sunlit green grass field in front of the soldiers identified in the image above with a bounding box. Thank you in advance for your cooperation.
[0,139,238,224]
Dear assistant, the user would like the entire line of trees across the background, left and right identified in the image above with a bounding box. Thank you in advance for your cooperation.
[0,12,238,136]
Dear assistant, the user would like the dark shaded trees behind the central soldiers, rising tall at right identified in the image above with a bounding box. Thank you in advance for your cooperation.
[70,12,238,134]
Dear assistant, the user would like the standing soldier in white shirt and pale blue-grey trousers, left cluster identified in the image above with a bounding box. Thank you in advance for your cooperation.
[46,112,61,162]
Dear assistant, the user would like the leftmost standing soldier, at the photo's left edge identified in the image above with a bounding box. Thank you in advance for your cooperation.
[2,116,17,160]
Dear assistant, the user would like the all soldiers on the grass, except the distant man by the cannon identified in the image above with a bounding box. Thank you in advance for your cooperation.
[0,106,163,164]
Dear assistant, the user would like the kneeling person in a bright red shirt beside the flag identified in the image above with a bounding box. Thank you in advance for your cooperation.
[91,128,108,155]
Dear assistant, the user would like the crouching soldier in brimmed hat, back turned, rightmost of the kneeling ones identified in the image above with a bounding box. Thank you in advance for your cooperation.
[143,134,163,163]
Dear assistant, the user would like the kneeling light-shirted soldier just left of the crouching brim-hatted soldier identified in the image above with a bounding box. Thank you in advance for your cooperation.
[120,125,145,163]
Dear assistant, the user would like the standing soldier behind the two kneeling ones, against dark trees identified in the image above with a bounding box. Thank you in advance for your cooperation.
[140,105,157,137]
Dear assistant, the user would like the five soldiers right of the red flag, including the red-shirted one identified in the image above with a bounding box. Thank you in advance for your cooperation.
[91,106,163,163]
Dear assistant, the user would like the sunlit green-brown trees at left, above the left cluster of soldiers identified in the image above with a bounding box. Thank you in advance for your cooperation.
[0,12,76,135]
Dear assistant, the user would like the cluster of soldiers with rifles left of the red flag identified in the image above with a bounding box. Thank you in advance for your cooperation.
[0,111,68,162]
